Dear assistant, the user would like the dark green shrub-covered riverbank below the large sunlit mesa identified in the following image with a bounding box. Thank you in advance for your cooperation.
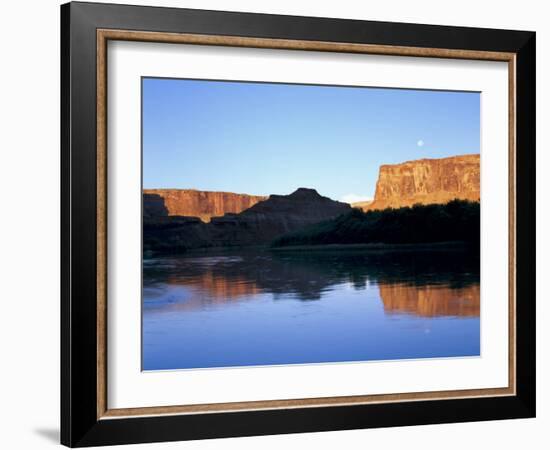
[271,200,480,248]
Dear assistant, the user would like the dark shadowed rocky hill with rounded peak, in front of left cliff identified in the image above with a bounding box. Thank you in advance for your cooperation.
[143,188,351,251]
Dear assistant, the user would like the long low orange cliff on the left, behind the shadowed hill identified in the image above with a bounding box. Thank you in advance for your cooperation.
[143,189,267,222]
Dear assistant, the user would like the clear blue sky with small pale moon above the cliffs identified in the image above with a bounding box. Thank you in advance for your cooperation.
[142,78,480,201]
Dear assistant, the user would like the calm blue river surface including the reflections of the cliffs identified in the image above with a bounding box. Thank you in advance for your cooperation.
[142,250,480,370]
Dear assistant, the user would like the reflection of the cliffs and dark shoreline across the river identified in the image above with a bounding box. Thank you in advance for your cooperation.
[144,250,479,317]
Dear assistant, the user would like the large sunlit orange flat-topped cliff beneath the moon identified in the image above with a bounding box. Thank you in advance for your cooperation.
[363,154,480,210]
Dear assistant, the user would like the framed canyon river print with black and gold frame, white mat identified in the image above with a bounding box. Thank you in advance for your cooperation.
[61,3,535,447]
